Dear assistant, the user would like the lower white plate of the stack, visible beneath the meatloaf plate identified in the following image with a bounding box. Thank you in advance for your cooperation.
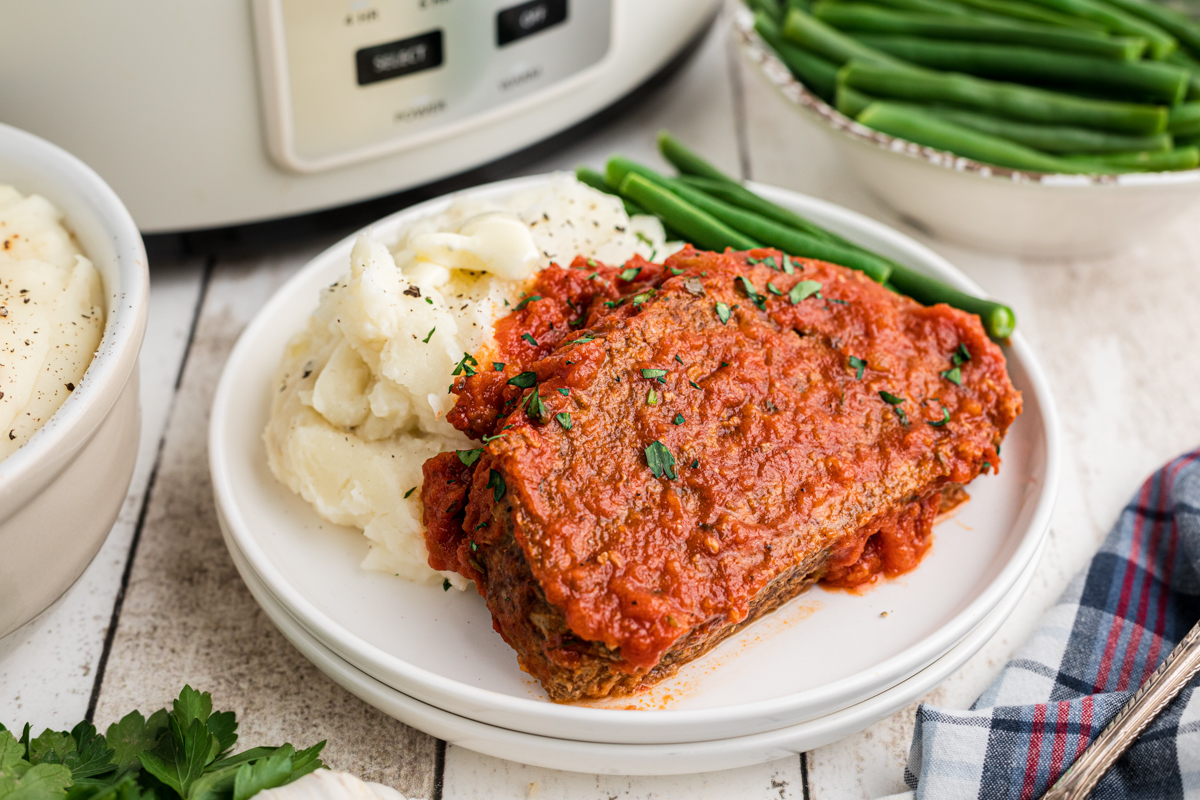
[218,515,1044,775]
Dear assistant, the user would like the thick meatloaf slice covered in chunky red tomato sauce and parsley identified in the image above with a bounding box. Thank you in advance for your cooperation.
[421,247,1021,699]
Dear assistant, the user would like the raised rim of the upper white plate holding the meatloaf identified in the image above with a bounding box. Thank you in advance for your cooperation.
[208,173,1061,735]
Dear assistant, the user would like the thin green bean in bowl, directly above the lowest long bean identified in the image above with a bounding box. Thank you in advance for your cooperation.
[916,105,1171,154]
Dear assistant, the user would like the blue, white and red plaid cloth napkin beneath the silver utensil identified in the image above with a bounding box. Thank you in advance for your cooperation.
[905,450,1200,800]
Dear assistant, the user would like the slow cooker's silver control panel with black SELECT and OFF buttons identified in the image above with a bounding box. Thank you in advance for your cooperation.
[253,0,613,172]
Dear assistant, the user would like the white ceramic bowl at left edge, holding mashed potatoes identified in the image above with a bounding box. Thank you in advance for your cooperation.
[0,125,150,655]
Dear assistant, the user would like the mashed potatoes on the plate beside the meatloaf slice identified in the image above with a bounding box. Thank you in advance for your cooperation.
[264,175,668,588]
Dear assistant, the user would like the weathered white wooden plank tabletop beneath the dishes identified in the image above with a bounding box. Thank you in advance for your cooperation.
[7,4,1200,800]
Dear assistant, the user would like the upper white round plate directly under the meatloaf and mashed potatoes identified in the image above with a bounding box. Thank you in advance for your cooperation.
[209,176,1058,744]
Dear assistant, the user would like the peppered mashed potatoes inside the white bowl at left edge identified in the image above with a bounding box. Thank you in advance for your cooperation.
[0,186,104,459]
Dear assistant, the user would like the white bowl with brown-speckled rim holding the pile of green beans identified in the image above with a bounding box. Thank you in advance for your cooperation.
[733,8,1200,258]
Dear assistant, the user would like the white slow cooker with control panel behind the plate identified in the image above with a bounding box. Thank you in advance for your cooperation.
[0,0,720,233]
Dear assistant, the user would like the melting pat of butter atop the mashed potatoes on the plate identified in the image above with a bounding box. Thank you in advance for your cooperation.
[408,212,540,281]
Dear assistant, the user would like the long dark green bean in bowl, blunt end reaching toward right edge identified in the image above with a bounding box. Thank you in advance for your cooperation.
[854,32,1188,104]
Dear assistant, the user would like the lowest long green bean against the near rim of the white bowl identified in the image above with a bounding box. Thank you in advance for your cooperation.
[858,102,1124,174]
